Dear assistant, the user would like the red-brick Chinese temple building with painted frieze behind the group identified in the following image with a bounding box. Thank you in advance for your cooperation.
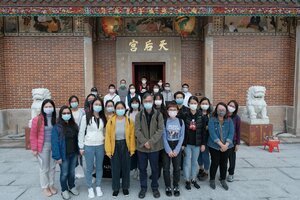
[0,0,300,135]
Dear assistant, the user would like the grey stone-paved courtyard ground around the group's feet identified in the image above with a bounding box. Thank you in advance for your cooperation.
[0,143,300,200]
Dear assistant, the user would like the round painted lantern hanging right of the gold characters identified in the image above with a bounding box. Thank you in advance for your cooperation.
[175,16,196,37]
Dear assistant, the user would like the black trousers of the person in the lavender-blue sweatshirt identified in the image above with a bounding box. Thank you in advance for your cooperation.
[163,141,181,187]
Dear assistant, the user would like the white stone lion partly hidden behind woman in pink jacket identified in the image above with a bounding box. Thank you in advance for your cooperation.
[29,88,51,127]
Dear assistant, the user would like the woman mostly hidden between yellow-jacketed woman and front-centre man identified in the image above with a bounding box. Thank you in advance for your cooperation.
[127,97,141,180]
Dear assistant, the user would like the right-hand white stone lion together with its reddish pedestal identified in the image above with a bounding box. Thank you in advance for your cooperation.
[241,86,273,146]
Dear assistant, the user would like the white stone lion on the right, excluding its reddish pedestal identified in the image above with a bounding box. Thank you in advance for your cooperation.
[246,86,269,121]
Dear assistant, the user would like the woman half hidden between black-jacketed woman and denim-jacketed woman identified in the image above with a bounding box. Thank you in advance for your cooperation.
[198,97,211,181]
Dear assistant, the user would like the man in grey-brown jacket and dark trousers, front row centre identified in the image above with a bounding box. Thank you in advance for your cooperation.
[135,93,164,199]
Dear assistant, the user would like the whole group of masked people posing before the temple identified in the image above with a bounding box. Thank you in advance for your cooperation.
[30,77,240,199]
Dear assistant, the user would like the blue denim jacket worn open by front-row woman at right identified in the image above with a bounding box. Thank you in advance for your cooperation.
[207,117,234,150]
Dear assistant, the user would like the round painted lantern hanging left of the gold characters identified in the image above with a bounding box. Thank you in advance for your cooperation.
[101,17,122,38]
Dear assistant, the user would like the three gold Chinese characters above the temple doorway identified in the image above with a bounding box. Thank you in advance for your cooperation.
[128,39,169,52]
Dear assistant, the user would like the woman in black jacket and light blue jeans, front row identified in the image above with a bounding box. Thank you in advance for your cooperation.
[183,96,207,190]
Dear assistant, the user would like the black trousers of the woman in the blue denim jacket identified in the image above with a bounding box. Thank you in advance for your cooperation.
[209,147,229,180]
